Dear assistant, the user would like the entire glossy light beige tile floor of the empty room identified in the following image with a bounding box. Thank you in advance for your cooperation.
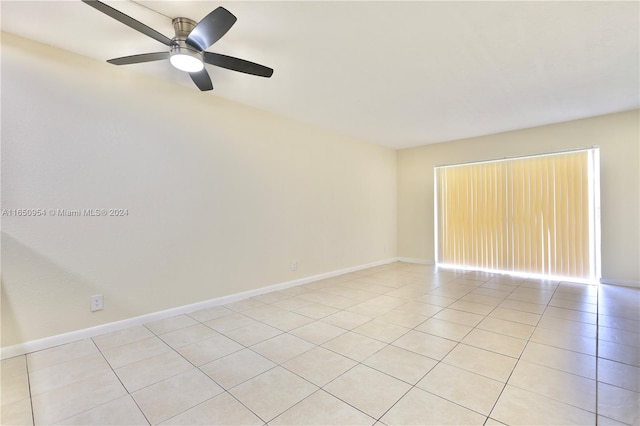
[1,263,640,426]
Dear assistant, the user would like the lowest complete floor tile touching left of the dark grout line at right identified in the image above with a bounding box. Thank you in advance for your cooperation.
[509,361,596,413]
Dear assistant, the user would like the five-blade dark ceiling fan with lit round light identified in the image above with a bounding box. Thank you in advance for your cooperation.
[82,0,273,91]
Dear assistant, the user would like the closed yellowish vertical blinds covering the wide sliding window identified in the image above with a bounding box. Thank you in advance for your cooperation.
[435,149,599,280]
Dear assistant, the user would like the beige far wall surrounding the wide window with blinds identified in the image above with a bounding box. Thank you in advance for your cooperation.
[398,110,640,282]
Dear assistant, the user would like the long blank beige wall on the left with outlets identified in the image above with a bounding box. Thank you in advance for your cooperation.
[2,34,397,346]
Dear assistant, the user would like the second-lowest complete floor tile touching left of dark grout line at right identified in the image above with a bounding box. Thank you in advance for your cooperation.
[520,342,596,379]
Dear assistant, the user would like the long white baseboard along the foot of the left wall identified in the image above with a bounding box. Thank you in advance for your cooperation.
[0,258,404,359]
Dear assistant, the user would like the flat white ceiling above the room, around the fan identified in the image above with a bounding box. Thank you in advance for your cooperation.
[0,0,640,148]
